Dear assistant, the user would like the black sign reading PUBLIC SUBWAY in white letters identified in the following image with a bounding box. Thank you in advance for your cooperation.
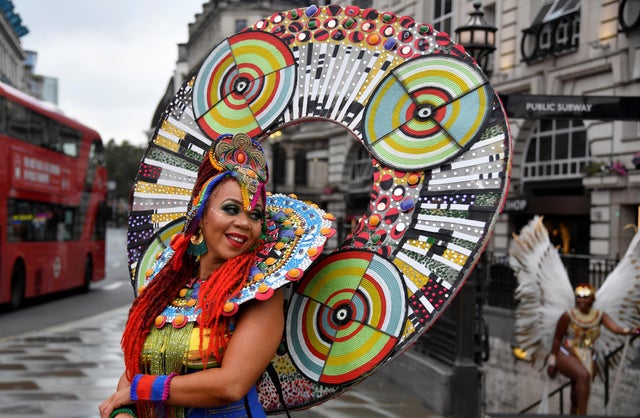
[499,94,640,120]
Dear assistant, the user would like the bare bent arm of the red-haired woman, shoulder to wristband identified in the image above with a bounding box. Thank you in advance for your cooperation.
[167,290,284,408]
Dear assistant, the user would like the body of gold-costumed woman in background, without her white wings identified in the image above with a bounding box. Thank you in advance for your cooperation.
[547,284,640,415]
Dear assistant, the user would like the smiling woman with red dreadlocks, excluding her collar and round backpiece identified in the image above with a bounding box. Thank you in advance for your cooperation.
[99,134,284,418]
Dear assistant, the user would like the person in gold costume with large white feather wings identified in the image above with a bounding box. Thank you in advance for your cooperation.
[509,216,640,415]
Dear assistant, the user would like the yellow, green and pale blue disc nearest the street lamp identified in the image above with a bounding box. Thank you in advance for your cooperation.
[363,56,492,170]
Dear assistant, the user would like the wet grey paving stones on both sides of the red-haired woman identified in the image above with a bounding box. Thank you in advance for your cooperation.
[0,306,442,418]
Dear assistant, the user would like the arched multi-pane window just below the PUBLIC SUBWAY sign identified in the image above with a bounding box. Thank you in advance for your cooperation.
[522,119,589,182]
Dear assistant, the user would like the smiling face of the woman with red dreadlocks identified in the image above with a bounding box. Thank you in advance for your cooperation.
[201,179,264,265]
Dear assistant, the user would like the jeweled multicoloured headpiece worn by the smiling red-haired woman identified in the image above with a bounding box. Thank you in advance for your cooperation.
[185,133,269,235]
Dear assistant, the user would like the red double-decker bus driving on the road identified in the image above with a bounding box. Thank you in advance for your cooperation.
[0,83,107,308]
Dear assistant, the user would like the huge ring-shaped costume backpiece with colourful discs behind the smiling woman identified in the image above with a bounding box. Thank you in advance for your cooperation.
[128,5,511,413]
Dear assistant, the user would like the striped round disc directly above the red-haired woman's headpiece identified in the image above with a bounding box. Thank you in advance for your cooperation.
[193,32,296,138]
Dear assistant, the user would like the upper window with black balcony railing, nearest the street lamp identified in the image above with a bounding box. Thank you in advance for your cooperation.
[520,0,580,62]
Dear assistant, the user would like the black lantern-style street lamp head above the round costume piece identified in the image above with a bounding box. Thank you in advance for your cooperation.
[456,1,498,75]
